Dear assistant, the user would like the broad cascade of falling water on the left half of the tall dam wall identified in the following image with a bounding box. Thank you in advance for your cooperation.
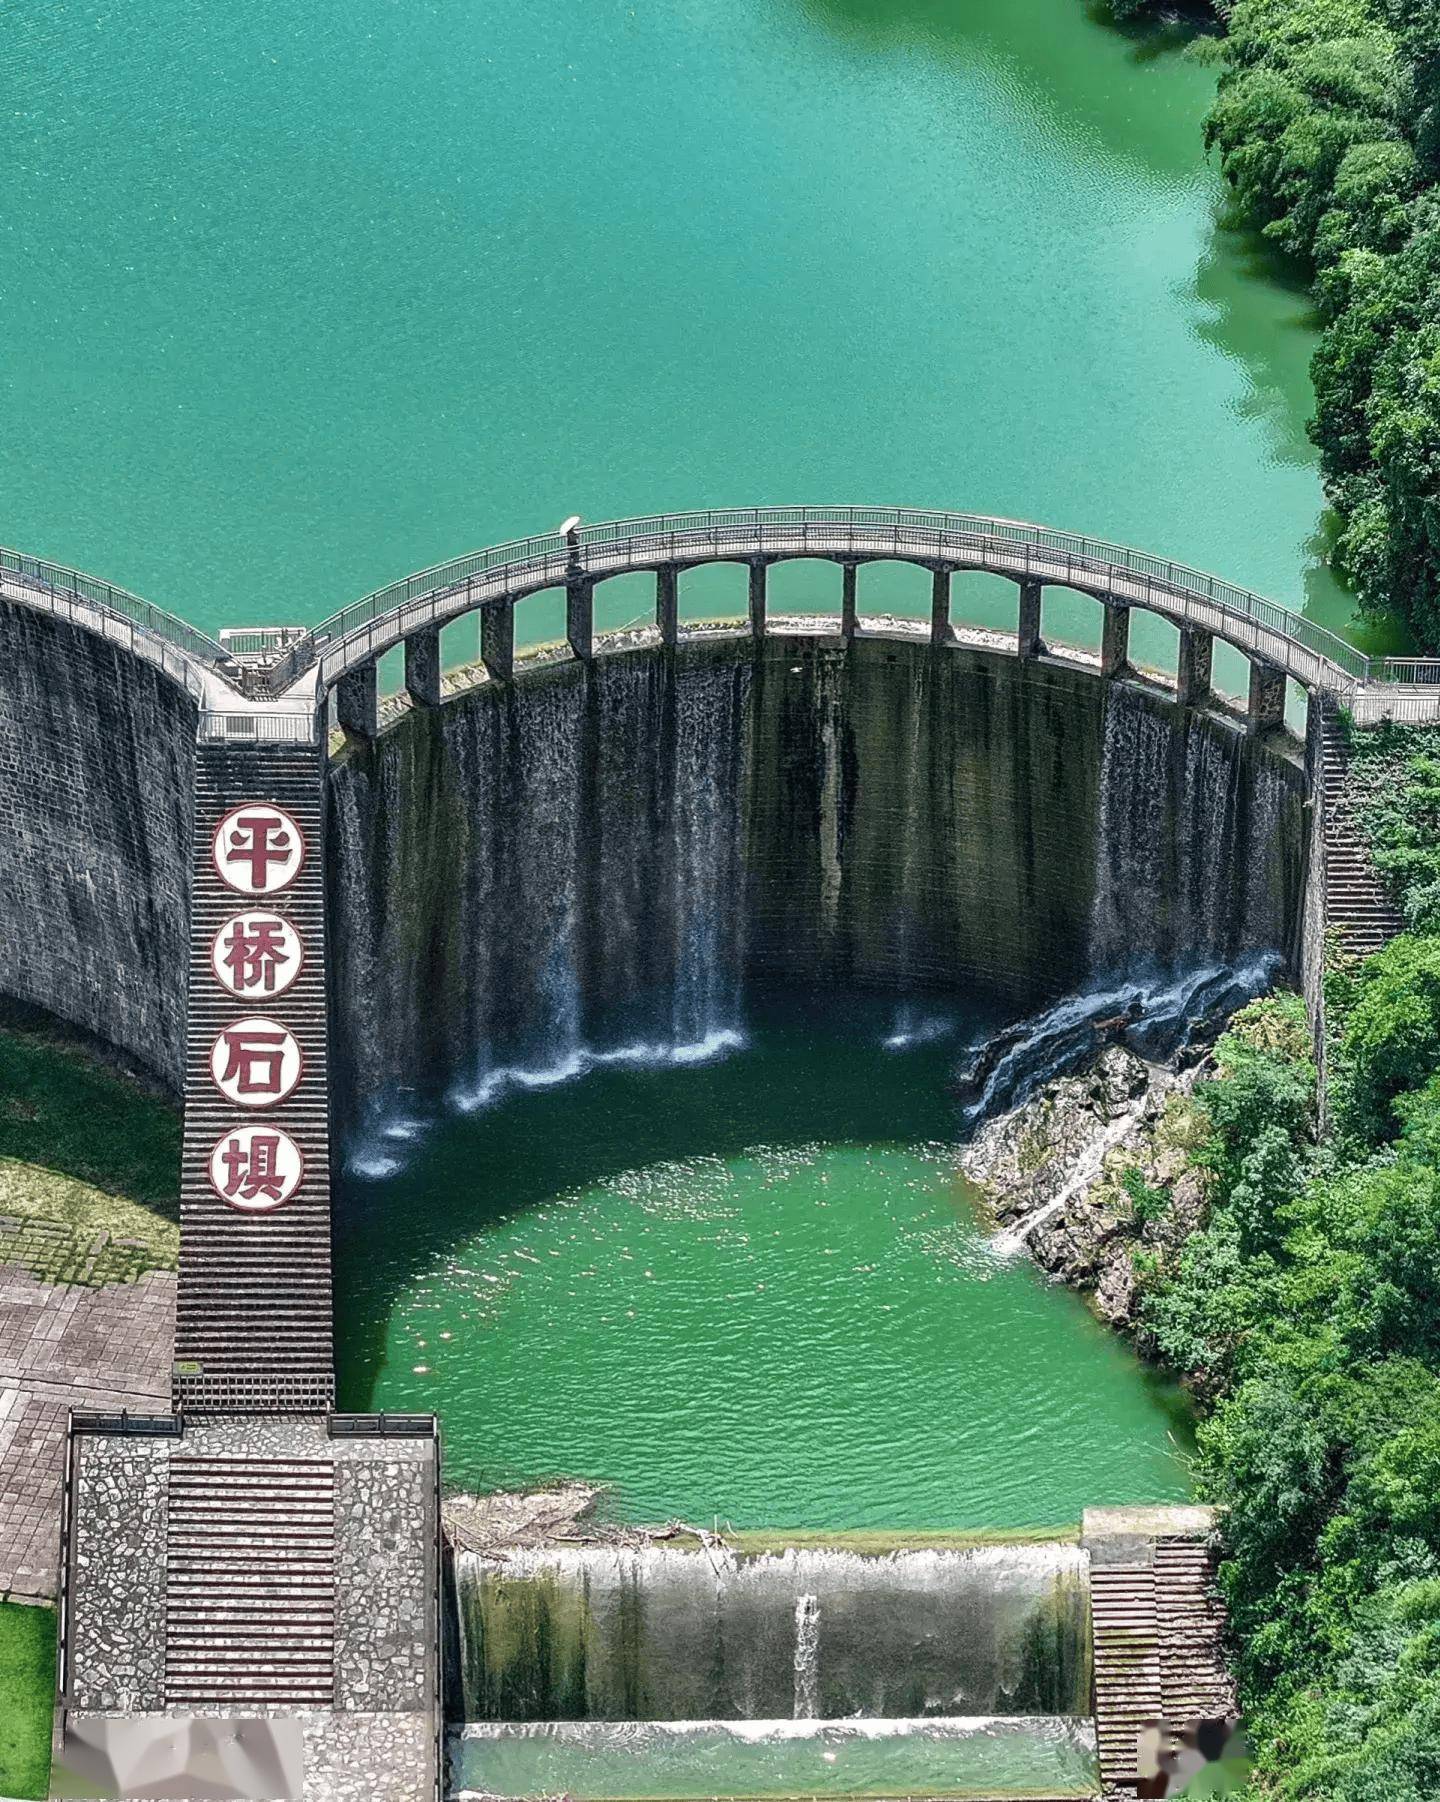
[332,660,748,1173]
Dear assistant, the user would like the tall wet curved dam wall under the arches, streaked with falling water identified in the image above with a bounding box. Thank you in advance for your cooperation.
[328,633,1305,1124]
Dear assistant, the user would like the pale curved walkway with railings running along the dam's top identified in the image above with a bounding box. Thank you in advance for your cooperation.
[0,506,1440,724]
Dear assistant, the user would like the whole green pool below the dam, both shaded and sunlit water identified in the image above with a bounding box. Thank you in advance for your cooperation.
[335,998,1188,1532]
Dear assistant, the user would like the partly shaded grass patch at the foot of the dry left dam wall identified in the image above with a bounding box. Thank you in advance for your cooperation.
[0,1024,180,1281]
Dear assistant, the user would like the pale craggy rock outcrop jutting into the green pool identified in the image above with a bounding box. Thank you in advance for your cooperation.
[961,1045,1208,1328]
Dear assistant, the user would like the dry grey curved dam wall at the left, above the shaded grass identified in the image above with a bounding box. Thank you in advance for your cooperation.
[0,600,196,1096]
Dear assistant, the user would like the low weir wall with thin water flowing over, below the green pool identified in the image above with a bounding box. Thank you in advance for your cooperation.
[456,1541,1090,1721]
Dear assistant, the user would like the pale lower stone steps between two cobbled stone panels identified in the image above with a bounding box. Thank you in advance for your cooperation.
[166,1456,335,1708]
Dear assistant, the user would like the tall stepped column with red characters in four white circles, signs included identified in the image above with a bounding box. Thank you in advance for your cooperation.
[173,744,335,1415]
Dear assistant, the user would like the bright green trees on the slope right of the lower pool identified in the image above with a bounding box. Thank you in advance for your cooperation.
[1135,728,1440,1802]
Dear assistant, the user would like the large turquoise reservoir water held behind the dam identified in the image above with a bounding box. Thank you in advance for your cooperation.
[0,0,1376,654]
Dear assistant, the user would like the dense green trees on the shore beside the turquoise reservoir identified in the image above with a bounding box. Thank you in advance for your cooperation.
[1116,0,1440,652]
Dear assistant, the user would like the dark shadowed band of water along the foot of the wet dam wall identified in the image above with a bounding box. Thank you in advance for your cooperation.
[335,995,1002,1406]
